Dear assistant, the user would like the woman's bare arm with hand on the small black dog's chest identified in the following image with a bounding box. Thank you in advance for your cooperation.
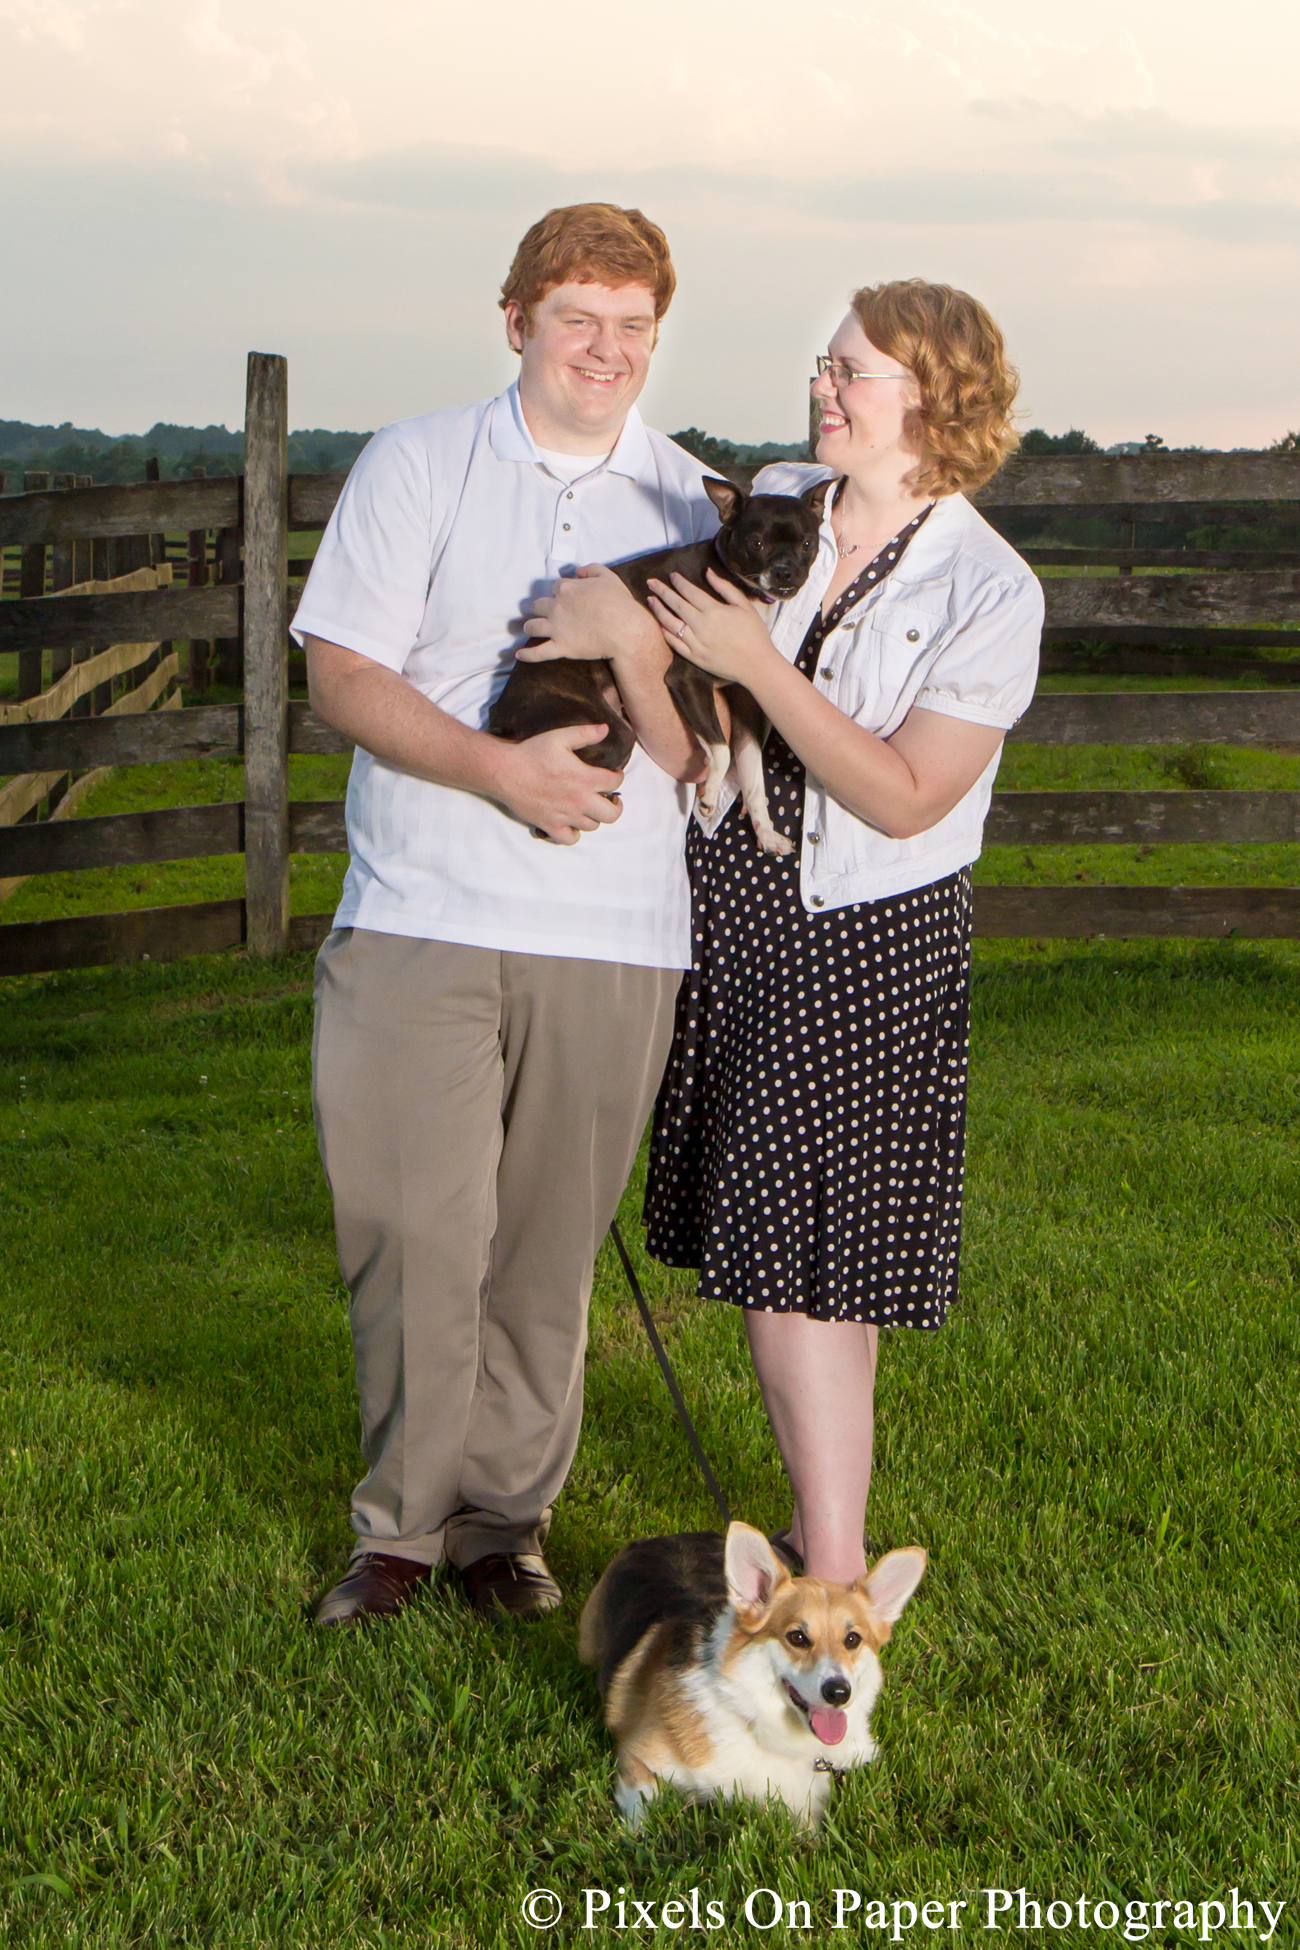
[651,575,1006,840]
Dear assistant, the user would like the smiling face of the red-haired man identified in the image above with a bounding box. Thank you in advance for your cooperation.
[505,285,657,454]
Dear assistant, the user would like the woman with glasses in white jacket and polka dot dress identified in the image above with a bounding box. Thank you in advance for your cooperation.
[647,279,1043,1581]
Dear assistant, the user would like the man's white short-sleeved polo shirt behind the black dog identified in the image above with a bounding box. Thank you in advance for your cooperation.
[292,384,717,967]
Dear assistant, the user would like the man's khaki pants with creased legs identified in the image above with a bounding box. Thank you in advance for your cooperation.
[312,928,682,1568]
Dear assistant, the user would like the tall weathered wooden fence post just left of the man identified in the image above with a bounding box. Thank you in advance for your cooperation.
[244,353,288,959]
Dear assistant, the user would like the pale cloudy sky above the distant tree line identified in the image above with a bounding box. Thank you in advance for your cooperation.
[0,0,1300,447]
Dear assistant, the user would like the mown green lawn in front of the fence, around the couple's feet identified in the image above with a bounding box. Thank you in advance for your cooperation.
[0,944,1300,1950]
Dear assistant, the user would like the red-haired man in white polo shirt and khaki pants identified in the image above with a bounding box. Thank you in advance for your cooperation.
[294,203,717,1624]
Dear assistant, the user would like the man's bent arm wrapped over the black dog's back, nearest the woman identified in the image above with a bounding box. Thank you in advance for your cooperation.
[518,564,707,786]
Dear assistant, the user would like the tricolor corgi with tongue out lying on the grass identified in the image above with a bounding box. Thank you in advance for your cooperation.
[579,1523,926,1829]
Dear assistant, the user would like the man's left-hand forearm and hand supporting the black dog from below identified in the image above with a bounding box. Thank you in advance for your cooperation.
[306,626,631,846]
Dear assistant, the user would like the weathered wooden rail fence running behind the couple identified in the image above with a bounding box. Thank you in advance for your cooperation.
[0,380,1300,975]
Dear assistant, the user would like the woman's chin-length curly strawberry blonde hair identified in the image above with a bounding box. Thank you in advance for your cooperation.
[850,277,1019,495]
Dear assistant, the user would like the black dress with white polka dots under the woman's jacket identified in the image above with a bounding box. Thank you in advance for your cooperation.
[645,511,971,1328]
